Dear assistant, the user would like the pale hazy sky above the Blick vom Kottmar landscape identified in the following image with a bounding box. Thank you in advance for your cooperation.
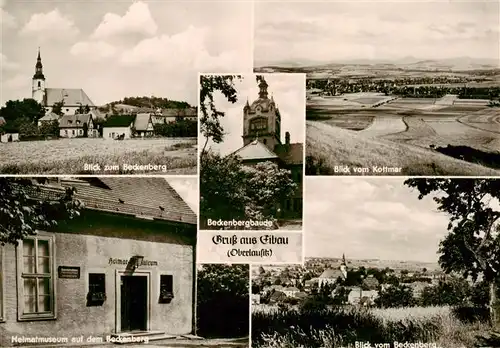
[254,0,500,66]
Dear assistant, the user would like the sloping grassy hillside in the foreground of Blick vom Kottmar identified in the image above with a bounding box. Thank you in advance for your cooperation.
[306,121,500,176]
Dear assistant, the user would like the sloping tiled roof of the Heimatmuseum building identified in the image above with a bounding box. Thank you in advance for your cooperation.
[25,177,197,225]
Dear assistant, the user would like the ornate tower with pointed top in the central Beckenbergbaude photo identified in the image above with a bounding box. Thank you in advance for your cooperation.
[243,78,281,151]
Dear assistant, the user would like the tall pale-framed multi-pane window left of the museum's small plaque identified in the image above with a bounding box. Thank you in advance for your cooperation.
[17,234,55,320]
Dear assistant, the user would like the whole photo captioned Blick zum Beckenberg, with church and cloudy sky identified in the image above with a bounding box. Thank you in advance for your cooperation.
[0,0,253,175]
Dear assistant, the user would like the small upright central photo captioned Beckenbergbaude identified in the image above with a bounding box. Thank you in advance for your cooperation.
[198,74,305,230]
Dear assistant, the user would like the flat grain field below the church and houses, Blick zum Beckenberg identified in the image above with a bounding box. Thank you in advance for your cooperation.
[0,138,197,174]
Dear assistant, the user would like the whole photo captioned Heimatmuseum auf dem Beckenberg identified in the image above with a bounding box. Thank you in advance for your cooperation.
[0,177,249,347]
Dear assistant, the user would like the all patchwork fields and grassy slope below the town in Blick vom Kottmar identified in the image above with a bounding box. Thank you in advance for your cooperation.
[306,93,500,175]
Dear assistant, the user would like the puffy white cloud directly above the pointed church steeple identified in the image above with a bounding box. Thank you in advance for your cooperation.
[20,8,79,41]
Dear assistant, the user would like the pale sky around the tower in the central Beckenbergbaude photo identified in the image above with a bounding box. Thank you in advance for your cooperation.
[200,74,306,156]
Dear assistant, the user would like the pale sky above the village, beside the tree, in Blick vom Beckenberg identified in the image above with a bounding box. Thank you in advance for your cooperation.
[304,177,449,262]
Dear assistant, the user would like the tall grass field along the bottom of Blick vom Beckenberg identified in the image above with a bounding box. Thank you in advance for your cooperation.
[252,307,488,348]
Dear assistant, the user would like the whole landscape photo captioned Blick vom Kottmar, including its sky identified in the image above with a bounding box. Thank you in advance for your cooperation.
[254,0,500,176]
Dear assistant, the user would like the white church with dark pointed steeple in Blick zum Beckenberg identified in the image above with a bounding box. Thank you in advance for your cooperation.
[31,49,96,115]
